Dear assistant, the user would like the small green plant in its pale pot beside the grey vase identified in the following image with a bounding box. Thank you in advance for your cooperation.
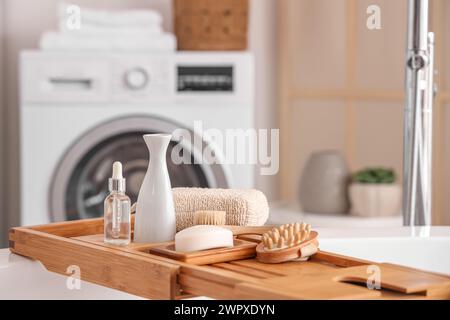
[349,168,401,217]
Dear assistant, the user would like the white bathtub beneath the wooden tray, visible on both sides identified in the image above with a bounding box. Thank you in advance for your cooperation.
[0,227,450,300]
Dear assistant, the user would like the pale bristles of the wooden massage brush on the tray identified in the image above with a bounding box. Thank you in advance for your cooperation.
[262,222,311,250]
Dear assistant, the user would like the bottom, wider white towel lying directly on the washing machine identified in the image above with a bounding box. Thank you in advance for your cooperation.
[39,31,177,51]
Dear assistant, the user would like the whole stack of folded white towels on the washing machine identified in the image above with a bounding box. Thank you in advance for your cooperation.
[39,4,177,52]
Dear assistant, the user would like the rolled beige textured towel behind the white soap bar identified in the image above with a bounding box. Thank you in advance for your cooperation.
[172,188,269,231]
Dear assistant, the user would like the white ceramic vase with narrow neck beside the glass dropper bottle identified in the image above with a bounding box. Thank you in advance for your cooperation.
[134,134,176,242]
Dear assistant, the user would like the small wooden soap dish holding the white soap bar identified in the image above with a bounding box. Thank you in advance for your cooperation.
[146,239,257,265]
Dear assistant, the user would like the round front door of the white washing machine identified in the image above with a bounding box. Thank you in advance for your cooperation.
[49,115,229,221]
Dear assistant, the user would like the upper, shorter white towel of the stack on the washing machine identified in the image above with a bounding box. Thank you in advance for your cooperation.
[58,3,162,27]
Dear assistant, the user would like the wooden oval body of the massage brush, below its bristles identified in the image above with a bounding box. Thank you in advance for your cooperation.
[256,231,319,263]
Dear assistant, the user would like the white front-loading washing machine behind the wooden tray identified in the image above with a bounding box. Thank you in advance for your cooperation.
[20,51,255,225]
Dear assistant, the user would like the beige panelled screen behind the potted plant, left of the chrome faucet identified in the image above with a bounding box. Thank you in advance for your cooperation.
[280,0,407,208]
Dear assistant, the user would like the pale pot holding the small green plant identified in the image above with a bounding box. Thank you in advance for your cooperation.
[349,183,402,217]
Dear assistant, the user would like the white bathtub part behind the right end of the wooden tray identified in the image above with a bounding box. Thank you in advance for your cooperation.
[319,227,450,275]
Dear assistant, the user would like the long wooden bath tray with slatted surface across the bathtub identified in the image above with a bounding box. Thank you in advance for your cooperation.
[9,219,450,299]
